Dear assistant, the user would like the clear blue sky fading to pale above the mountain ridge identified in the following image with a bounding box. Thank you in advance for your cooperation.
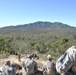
[0,0,76,27]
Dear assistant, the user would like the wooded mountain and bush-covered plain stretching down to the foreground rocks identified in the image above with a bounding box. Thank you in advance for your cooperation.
[0,21,76,58]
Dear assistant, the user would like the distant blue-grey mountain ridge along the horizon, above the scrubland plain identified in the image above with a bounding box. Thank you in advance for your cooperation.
[0,21,76,34]
